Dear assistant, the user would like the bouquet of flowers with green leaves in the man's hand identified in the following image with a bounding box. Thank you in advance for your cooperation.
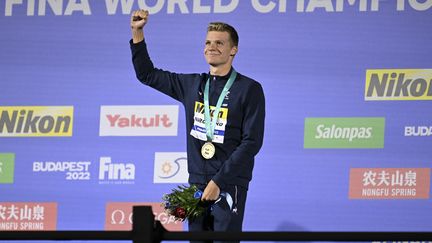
[162,185,208,221]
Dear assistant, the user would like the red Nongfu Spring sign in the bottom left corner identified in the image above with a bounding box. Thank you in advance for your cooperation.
[0,202,57,231]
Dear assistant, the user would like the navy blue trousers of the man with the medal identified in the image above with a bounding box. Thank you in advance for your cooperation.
[188,185,247,243]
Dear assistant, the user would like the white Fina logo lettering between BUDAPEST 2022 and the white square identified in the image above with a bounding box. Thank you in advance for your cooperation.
[99,157,135,184]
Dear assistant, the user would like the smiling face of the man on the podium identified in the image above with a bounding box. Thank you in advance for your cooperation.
[204,31,237,67]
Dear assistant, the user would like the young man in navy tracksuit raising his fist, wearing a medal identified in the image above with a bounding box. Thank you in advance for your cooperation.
[130,10,265,236]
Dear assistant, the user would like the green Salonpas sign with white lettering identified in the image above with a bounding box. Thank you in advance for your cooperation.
[304,117,385,148]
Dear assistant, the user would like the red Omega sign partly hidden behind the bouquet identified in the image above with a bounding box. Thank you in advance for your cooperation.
[105,202,183,231]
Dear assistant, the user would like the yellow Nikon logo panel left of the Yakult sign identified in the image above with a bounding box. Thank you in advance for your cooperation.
[0,106,73,137]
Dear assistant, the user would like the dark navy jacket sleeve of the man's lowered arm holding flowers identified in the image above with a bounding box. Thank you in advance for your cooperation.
[212,83,265,190]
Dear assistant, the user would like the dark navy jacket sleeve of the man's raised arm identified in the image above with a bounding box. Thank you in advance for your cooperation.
[129,40,187,102]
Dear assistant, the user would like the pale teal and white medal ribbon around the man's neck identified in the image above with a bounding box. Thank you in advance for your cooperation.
[204,69,237,142]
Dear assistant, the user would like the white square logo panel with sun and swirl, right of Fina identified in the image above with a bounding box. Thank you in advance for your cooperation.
[153,152,189,183]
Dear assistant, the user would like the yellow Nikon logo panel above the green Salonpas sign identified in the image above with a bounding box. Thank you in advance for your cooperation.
[365,69,432,100]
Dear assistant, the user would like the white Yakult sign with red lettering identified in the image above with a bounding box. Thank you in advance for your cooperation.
[99,106,178,136]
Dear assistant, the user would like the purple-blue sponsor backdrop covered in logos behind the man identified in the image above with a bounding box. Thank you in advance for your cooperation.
[0,0,432,236]
